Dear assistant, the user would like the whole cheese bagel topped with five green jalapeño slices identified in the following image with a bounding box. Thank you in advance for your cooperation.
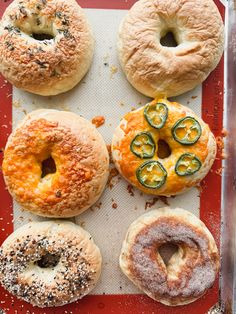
[112,99,216,196]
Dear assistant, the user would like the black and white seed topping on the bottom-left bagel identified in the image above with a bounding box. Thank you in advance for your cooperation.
[0,234,95,306]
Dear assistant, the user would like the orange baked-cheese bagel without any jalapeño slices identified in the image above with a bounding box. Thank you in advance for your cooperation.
[3,109,109,217]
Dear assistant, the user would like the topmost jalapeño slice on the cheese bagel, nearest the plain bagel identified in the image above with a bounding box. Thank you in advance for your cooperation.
[144,103,168,129]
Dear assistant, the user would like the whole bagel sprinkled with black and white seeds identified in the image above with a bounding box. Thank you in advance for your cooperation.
[0,221,102,307]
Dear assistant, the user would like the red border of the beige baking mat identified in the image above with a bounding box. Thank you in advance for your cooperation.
[0,0,225,314]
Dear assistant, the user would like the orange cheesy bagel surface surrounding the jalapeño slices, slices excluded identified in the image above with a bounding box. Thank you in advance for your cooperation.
[112,99,216,196]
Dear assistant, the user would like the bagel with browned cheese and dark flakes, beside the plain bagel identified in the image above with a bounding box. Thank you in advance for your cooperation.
[0,0,94,96]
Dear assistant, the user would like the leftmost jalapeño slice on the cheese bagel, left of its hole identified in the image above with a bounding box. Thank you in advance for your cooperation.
[130,132,156,158]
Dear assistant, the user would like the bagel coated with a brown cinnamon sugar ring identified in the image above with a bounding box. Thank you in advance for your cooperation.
[120,208,219,306]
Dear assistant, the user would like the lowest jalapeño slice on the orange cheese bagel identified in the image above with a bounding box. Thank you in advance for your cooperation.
[136,160,167,189]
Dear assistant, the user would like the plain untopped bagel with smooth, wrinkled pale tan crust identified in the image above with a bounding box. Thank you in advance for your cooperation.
[118,0,224,98]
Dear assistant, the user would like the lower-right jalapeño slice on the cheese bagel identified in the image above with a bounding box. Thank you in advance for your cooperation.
[175,153,202,176]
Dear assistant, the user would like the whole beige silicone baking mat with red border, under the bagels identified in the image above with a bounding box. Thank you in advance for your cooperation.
[0,0,224,314]
